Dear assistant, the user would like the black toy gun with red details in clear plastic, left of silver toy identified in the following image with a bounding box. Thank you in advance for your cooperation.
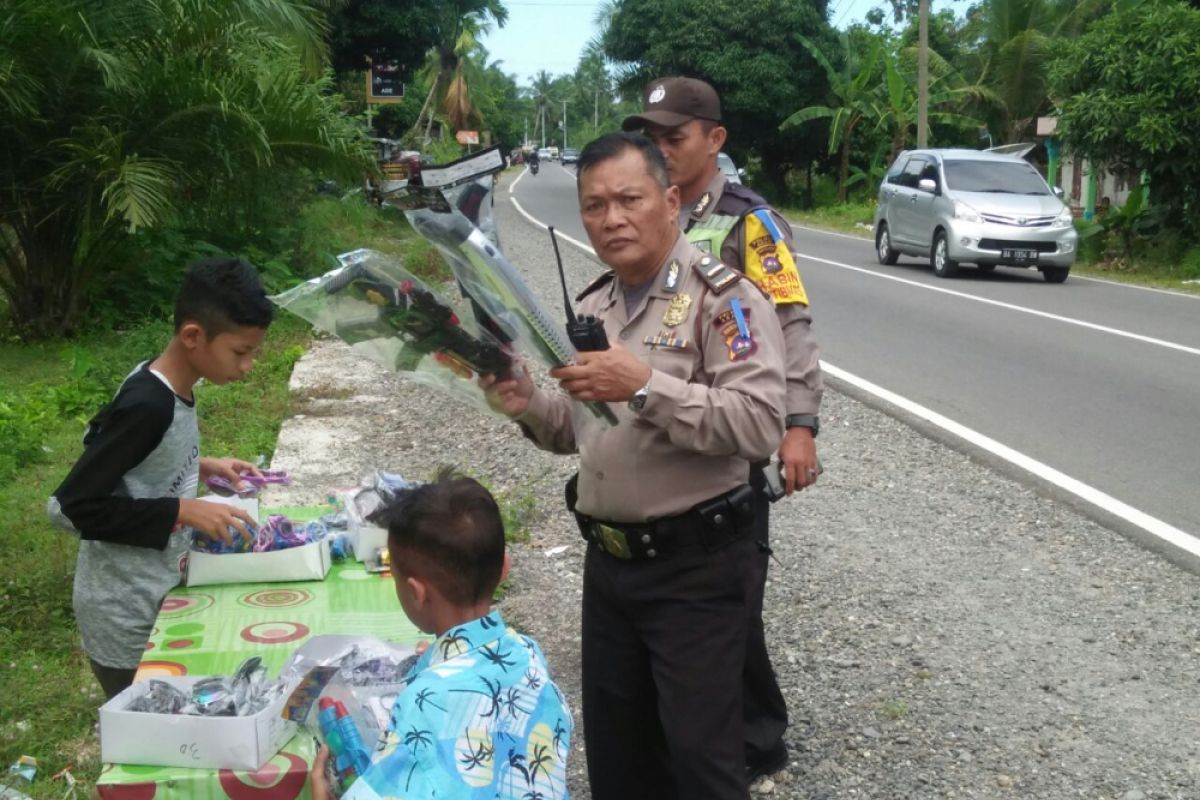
[325,264,512,377]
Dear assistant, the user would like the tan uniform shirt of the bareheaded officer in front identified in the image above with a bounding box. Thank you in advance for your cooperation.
[518,234,785,522]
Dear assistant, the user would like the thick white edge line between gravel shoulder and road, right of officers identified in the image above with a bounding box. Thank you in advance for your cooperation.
[821,361,1200,557]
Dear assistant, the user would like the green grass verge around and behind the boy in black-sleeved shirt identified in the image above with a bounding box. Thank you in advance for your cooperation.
[0,198,449,800]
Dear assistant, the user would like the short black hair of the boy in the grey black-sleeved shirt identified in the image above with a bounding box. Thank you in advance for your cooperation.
[175,258,275,339]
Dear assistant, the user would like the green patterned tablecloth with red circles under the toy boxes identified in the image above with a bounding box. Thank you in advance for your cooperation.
[96,509,420,800]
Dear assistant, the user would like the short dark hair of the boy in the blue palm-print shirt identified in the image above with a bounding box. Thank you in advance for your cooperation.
[371,468,504,606]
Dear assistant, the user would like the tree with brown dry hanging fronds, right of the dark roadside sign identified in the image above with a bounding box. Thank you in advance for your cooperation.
[413,0,509,144]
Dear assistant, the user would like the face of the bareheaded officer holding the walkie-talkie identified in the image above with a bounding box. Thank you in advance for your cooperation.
[580,149,679,282]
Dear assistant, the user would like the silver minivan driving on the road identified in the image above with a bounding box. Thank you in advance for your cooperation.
[875,150,1079,283]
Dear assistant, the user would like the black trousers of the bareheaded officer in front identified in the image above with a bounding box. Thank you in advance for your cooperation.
[583,536,757,800]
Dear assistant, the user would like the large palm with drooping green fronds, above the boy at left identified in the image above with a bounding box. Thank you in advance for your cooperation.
[0,0,372,336]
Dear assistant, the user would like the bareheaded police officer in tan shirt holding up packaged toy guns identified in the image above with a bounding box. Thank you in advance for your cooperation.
[485,133,785,800]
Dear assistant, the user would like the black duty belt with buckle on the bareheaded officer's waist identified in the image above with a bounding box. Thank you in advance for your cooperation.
[566,475,755,560]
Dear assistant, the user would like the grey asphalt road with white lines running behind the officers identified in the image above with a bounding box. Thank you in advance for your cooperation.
[498,163,1200,563]
